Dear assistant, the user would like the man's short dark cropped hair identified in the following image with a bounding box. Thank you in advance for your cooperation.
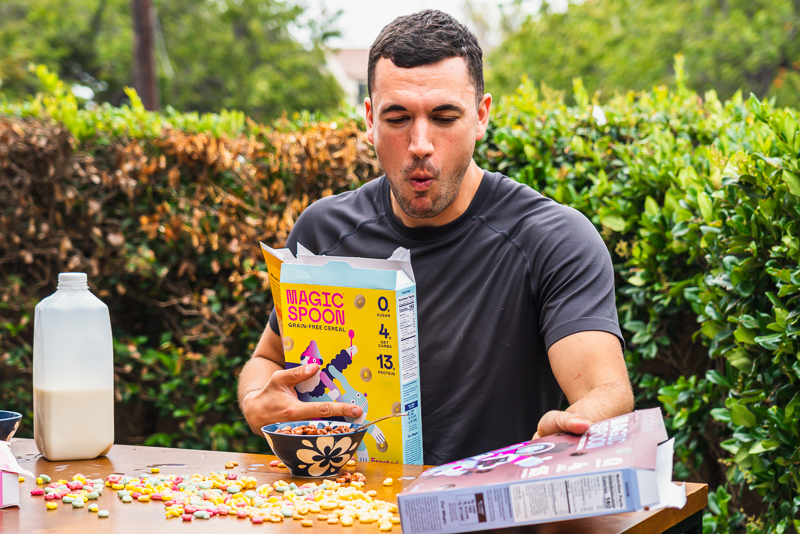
[367,9,483,104]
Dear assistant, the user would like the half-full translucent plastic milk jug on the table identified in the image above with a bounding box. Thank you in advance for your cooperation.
[33,273,114,460]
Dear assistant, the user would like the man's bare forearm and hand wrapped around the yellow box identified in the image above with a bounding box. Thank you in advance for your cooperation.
[238,324,361,434]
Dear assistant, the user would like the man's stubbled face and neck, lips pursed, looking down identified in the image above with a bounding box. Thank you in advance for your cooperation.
[365,57,491,226]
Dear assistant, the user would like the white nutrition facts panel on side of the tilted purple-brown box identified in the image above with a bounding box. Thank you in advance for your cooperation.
[511,472,626,523]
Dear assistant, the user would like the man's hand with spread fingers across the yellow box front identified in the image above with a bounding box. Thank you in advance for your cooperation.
[242,364,361,433]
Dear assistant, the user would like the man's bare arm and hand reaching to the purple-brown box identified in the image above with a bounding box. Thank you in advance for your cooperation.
[534,331,633,437]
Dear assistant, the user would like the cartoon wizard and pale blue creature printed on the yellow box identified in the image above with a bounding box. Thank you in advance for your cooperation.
[295,340,386,462]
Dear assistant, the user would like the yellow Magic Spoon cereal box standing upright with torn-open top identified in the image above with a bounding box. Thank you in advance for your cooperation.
[262,244,422,465]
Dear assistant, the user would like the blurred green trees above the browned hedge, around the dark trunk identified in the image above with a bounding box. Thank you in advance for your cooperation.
[0,0,342,120]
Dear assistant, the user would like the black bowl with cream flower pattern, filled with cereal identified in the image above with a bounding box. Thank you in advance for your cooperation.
[261,421,367,478]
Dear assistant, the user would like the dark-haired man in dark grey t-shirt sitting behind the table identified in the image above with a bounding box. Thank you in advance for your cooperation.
[239,10,633,464]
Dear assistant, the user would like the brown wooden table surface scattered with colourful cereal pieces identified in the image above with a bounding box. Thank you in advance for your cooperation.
[0,439,708,534]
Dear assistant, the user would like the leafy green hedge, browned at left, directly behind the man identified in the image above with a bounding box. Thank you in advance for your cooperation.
[0,63,800,532]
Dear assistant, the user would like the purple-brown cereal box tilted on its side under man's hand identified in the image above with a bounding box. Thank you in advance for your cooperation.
[397,408,686,534]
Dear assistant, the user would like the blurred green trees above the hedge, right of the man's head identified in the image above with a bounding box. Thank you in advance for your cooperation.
[486,0,800,106]
